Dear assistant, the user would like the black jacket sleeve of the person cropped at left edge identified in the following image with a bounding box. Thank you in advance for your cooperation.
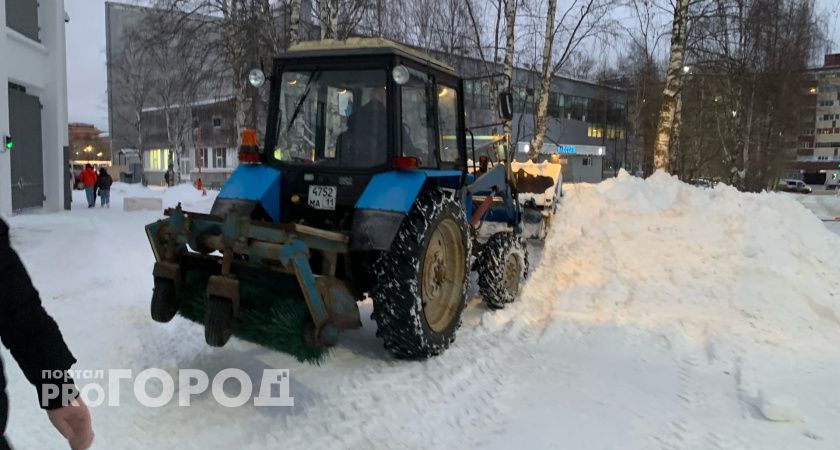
[0,220,76,409]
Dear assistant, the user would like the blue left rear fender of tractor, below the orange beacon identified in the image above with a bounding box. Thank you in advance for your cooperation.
[211,164,281,223]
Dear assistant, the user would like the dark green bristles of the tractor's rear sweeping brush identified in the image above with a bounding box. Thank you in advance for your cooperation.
[179,271,327,364]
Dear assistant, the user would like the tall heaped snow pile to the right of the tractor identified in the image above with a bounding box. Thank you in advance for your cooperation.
[523,172,840,351]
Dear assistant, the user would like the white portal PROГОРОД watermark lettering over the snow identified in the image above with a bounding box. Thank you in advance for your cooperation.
[41,368,295,408]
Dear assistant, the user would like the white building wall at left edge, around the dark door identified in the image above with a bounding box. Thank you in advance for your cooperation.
[0,0,69,215]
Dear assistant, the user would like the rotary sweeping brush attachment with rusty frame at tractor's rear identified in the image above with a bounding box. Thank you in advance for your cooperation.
[146,205,361,359]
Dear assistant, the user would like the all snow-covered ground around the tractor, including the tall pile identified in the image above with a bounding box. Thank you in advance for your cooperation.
[3,174,840,449]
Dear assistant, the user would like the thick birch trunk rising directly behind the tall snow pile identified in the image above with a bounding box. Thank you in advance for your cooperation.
[653,0,689,172]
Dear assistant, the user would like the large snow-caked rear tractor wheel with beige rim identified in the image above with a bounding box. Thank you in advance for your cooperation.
[372,189,470,359]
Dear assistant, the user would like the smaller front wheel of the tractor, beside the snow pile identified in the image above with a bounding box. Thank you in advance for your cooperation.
[478,232,528,309]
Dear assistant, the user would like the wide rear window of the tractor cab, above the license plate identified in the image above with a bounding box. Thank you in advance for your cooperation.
[273,70,388,168]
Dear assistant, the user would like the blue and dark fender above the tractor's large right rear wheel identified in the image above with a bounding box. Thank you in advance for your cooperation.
[350,170,463,251]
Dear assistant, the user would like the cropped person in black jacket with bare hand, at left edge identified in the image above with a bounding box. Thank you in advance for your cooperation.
[0,219,93,450]
